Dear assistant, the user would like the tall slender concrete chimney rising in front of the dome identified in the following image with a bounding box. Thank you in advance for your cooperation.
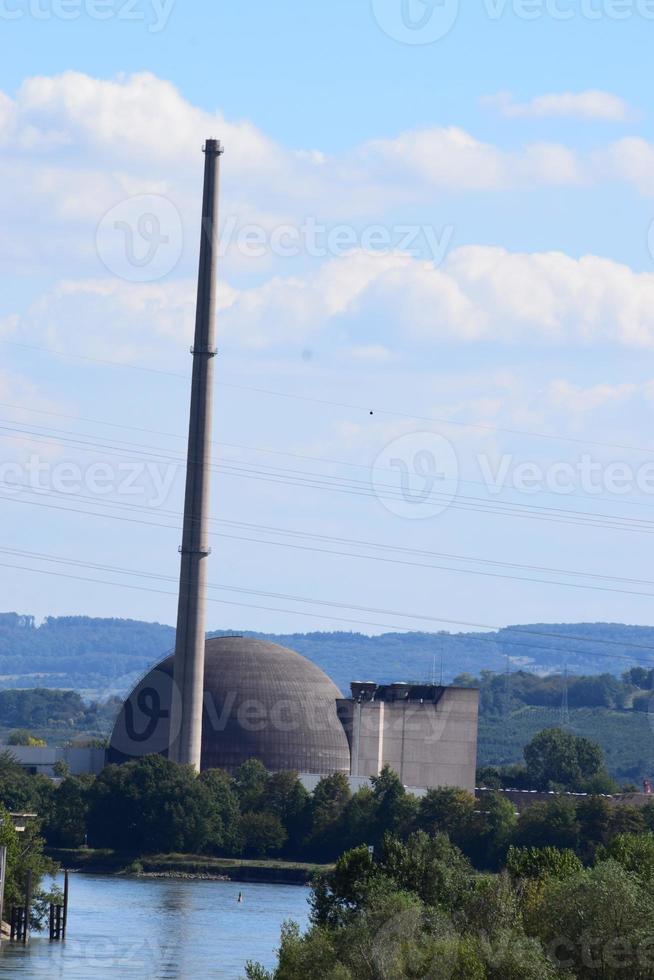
[168,140,223,770]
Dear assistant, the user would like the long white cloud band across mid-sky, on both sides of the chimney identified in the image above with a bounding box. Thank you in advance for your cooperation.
[10,246,654,358]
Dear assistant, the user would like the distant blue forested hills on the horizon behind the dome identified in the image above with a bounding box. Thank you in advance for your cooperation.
[0,613,654,697]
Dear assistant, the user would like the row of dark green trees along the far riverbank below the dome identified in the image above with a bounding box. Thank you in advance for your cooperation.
[0,729,654,871]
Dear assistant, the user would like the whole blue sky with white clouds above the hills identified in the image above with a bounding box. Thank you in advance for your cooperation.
[0,0,654,660]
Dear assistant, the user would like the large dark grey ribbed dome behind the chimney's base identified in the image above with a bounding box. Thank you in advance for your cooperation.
[109,637,350,774]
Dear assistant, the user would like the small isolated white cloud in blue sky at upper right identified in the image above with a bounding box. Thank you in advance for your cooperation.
[481,89,634,122]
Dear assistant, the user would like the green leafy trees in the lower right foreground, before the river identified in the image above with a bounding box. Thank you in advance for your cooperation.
[246,832,654,980]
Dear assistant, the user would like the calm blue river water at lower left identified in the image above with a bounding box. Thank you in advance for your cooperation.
[0,874,309,980]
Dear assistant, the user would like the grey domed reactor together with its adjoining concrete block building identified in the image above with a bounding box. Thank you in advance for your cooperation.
[108,637,479,792]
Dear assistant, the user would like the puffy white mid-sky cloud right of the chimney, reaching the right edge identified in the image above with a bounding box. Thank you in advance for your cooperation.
[223,246,654,348]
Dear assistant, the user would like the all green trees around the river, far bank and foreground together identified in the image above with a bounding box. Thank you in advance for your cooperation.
[0,729,654,980]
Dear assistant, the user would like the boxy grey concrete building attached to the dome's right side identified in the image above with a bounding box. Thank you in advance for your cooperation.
[338,688,479,793]
